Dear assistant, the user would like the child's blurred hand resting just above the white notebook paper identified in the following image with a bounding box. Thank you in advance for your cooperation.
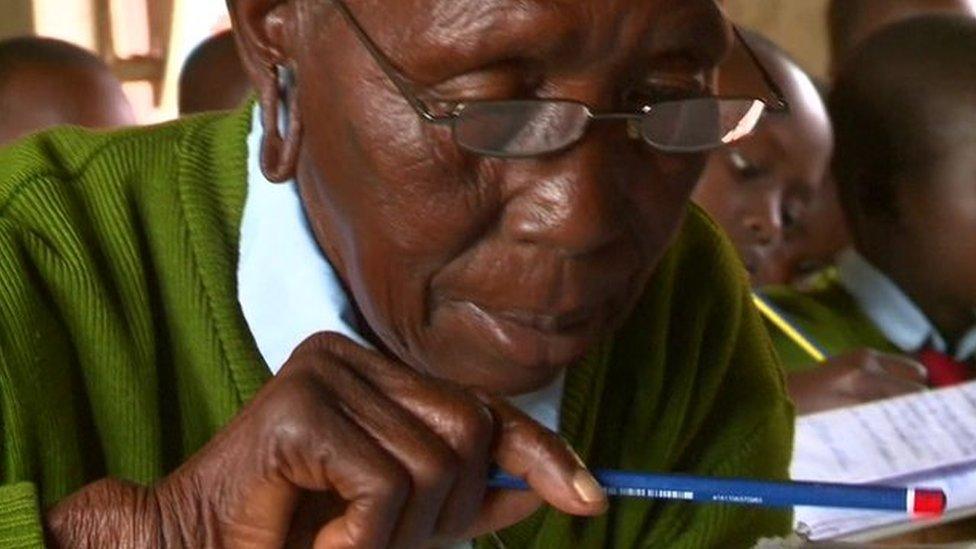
[787,349,926,415]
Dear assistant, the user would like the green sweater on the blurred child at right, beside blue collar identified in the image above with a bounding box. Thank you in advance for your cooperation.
[761,269,901,372]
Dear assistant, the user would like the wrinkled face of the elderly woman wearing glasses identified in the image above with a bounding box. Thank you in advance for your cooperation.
[295,0,727,393]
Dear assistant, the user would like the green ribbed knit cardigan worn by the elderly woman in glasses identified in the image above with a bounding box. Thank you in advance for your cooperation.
[0,110,793,547]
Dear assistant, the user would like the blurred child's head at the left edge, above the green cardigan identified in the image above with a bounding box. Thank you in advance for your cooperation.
[0,37,135,145]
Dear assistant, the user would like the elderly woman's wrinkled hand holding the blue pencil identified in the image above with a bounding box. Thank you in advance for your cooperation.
[47,334,606,548]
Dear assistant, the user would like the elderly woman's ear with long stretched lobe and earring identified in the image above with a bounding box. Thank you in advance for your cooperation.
[228,0,302,183]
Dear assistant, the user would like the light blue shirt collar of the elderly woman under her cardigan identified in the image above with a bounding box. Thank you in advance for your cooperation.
[237,107,565,431]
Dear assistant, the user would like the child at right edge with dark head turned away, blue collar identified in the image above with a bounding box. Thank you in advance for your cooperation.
[765,15,976,411]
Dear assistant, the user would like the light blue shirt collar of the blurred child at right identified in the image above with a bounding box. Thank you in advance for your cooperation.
[837,249,976,361]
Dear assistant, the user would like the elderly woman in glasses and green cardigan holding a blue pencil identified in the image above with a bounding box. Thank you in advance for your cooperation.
[0,0,792,547]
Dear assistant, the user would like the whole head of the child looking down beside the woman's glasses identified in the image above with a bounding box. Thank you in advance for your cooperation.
[694,33,840,286]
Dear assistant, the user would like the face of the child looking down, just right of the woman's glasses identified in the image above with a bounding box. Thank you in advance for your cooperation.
[695,108,836,286]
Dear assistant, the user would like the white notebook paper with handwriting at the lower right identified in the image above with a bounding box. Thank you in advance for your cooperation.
[790,382,976,540]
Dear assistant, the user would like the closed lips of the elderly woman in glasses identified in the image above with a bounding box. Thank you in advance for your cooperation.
[449,301,599,367]
